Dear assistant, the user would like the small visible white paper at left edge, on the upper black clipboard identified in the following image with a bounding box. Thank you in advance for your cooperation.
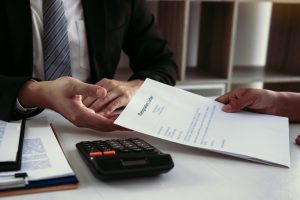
[0,121,22,162]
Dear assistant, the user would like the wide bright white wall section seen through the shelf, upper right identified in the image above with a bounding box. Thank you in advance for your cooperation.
[234,2,272,66]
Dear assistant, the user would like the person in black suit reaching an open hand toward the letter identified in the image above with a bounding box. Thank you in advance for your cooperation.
[0,0,177,131]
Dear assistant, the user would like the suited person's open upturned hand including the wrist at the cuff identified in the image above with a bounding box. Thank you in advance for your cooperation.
[18,77,122,131]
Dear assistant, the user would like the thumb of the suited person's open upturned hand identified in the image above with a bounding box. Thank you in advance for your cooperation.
[73,82,107,98]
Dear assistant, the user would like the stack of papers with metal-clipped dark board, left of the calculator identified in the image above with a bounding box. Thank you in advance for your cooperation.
[0,118,78,196]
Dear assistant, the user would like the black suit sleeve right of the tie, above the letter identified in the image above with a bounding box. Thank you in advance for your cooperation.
[123,0,177,85]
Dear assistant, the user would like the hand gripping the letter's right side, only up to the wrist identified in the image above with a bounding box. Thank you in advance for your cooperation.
[216,88,277,114]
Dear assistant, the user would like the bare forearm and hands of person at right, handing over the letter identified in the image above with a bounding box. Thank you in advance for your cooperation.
[216,88,300,145]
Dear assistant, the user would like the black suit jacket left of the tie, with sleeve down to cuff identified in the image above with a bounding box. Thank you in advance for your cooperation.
[0,1,41,121]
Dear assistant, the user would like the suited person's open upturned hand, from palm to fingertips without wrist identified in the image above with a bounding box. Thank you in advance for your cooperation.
[44,77,123,131]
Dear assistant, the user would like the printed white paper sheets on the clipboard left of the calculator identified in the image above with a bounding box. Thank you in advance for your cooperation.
[0,117,75,183]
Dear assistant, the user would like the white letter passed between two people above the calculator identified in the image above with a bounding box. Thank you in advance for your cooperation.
[115,79,290,167]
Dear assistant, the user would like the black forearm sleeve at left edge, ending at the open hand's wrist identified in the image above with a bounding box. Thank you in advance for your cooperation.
[0,76,42,121]
